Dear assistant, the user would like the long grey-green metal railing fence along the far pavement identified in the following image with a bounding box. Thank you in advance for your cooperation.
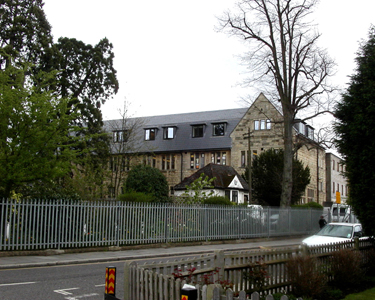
[0,199,322,251]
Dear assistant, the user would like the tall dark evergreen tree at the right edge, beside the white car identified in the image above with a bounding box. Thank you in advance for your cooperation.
[335,27,375,235]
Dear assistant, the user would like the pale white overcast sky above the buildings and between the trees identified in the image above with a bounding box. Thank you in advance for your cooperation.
[44,0,375,119]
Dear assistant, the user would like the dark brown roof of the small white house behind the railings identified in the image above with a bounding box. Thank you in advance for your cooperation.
[174,163,249,191]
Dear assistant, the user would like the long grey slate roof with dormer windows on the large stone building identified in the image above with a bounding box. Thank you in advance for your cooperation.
[104,108,248,153]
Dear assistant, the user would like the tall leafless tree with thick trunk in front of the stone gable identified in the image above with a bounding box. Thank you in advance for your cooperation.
[219,0,334,207]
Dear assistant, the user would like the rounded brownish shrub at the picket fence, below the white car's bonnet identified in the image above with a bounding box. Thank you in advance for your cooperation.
[286,256,327,299]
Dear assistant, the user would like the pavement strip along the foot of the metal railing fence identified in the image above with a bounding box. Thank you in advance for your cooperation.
[0,236,304,269]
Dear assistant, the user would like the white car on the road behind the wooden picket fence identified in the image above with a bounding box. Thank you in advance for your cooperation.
[302,223,362,246]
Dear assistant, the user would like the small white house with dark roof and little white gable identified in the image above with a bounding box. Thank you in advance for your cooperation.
[174,163,249,203]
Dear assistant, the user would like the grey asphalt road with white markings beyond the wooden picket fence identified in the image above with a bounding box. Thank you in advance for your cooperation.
[0,240,304,300]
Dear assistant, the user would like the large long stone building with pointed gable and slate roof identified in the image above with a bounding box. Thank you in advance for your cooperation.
[105,94,325,203]
